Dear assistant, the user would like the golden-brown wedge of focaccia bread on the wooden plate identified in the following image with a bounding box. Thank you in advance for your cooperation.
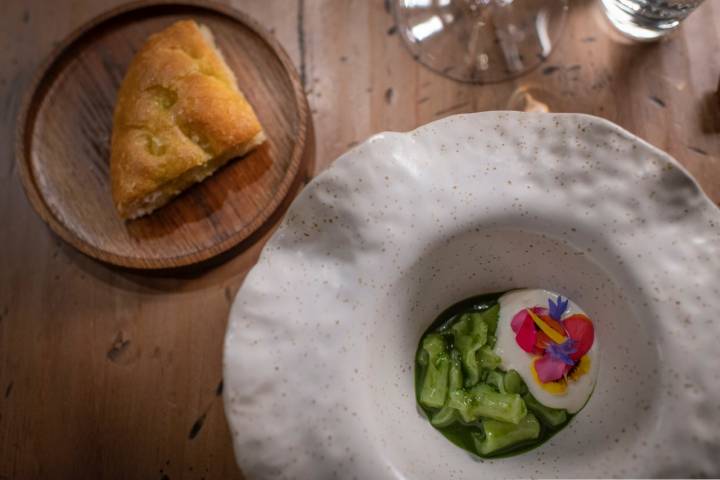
[110,20,265,219]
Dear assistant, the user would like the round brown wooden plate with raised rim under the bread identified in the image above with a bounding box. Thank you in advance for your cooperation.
[17,1,310,269]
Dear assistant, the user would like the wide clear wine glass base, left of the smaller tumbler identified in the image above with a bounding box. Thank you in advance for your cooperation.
[393,0,568,83]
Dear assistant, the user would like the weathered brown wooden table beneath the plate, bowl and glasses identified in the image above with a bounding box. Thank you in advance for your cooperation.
[0,0,720,480]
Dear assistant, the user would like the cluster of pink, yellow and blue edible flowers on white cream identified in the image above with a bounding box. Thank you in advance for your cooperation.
[510,296,595,395]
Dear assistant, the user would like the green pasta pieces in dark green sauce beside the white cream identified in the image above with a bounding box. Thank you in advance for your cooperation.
[415,292,573,458]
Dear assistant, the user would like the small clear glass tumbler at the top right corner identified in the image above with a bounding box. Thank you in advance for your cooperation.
[602,0,703,40]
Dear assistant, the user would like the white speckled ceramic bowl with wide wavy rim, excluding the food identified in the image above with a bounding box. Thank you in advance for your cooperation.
[225,112,720,480]
